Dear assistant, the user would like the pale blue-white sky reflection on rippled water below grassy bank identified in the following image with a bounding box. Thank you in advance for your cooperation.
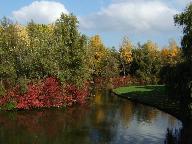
[113,104,182,144]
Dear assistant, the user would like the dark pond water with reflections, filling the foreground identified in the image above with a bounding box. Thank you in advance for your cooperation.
[0,89,182,144]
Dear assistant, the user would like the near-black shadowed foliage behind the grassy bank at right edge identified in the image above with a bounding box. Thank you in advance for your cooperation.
[161,62,192,99]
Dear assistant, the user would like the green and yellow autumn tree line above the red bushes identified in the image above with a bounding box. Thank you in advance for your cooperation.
[0,6,191,110]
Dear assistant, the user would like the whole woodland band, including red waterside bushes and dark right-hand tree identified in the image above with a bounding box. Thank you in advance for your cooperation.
[0,5,192,112]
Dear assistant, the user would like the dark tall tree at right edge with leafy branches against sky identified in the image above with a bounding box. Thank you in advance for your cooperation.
[174,3,192,103]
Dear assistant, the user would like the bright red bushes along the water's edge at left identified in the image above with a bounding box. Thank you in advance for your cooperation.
[0,77,88,109]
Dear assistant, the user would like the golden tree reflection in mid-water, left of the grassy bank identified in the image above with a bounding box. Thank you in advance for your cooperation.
[89,91,118,144]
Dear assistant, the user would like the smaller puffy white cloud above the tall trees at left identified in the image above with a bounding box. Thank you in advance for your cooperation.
[12,1,69,23]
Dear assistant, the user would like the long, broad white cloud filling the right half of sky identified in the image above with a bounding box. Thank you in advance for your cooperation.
[80,0,178,33]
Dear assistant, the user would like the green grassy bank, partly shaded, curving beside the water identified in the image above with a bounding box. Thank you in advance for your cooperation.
[113,85,181,119]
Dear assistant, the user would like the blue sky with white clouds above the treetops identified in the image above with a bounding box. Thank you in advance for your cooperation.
[0,0,192,48]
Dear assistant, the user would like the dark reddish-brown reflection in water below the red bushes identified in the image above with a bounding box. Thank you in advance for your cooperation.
[0,107,89,144]
